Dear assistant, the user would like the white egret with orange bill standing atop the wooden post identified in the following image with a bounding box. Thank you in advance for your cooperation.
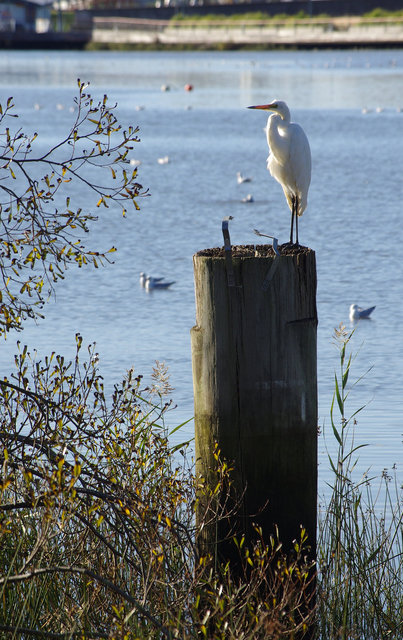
[248,100,311,244]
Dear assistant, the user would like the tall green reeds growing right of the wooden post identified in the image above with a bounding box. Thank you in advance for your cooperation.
[318,327,403,640]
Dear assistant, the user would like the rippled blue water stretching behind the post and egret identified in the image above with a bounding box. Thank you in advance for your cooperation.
[0,51,403,491]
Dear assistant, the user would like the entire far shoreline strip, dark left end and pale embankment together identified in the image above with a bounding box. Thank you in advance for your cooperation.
[0,12,403,50]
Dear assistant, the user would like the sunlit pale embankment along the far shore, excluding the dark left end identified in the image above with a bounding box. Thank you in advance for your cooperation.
[91,16,403,48]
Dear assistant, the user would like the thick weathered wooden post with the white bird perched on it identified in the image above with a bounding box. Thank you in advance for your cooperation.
[191,245,317,559]
